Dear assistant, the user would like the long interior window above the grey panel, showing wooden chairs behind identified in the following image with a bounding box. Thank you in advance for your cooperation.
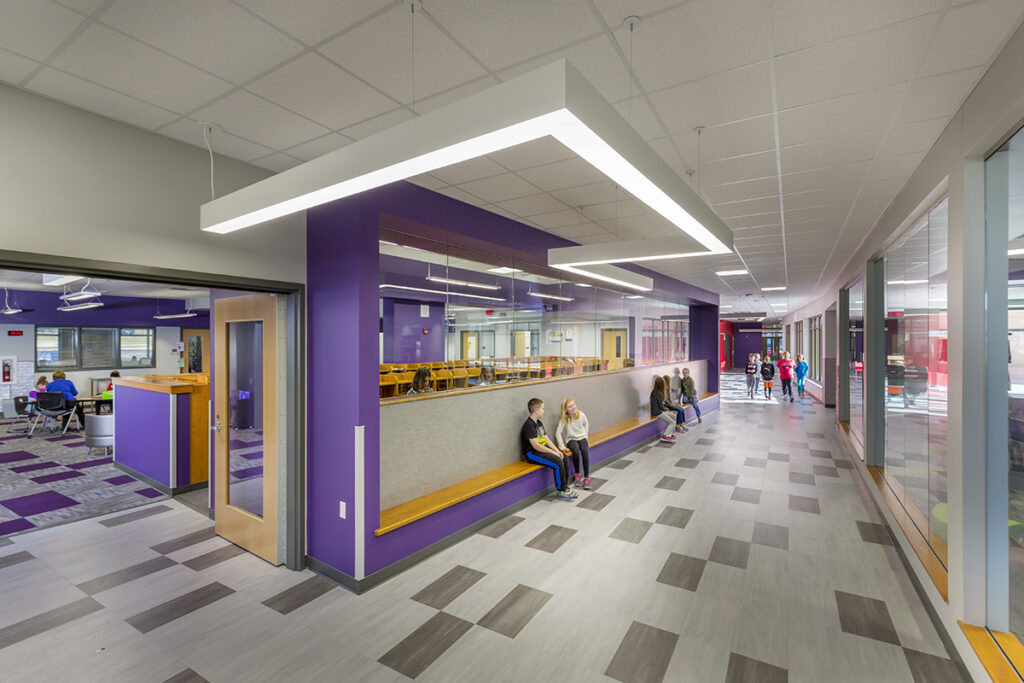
[379,229,689,399]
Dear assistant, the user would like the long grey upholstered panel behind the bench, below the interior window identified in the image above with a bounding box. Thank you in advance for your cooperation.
[381,360,708,509]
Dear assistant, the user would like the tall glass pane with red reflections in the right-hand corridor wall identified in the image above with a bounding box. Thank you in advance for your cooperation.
[880,200,948,566]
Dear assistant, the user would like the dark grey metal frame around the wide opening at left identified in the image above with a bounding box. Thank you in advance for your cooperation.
[0,249,306,570]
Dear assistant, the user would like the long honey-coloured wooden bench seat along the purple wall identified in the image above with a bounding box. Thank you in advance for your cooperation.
[374,413,655,536]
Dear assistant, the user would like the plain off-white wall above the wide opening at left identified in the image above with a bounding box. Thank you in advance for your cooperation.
[0,85,305,283]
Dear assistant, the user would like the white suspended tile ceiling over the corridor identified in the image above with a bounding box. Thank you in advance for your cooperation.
[0,0,1024,314]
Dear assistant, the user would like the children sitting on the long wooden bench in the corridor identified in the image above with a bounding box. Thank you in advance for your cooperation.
[519,368,703,501]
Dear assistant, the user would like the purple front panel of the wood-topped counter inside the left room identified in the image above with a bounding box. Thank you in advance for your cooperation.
[114,386,171,487]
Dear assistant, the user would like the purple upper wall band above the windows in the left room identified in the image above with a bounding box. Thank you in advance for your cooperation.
[3,291,210,328]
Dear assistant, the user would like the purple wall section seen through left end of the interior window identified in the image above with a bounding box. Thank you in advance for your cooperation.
[383,298,444,362]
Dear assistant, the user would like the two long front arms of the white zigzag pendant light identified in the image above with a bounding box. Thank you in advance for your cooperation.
[200,59,732,255]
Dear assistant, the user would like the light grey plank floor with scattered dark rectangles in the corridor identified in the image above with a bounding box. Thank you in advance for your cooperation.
[0,375,962,683]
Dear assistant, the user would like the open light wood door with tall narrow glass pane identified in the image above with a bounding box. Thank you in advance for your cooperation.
[213,294,285,564]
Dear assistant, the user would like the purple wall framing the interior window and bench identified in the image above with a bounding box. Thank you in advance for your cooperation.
[306,182,718,589]
